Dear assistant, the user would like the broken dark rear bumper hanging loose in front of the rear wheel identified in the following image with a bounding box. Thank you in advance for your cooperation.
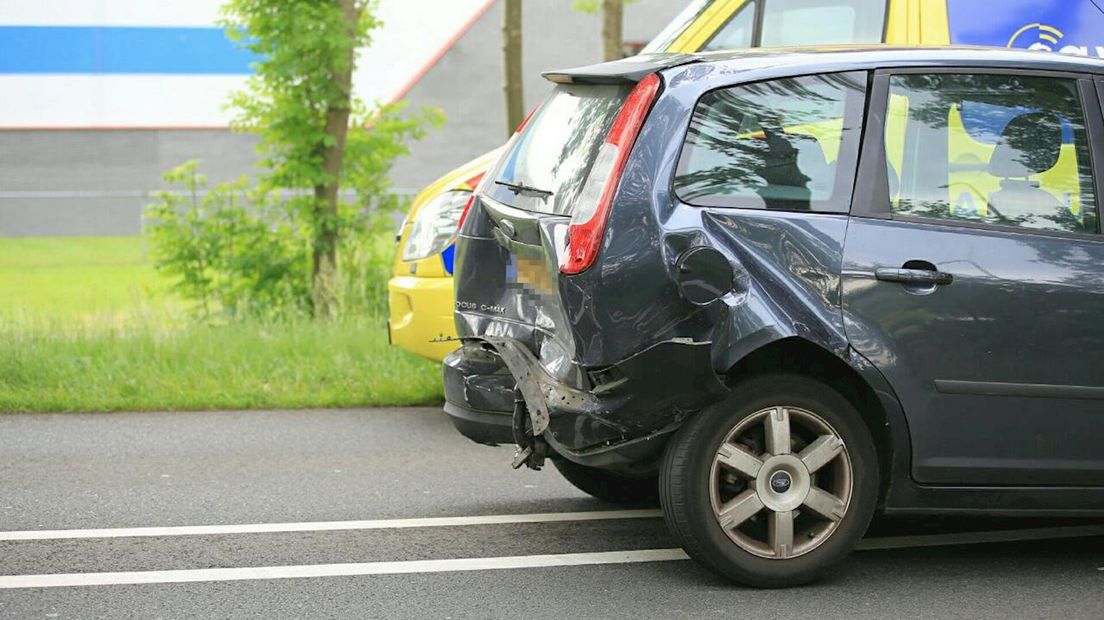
[444,336,728,467]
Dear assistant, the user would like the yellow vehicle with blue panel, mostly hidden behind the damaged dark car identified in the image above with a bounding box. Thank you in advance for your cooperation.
[388,0,1104,361]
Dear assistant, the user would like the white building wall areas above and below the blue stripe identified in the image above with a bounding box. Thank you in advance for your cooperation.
[0,0,493,128]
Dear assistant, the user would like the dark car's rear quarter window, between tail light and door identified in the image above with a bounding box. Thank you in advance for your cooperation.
[675,72,867,213]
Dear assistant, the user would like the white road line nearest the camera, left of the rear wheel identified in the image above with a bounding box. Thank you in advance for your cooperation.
[0,549,688,589]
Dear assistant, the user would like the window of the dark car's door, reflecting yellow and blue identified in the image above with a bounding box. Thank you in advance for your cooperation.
[885,74,1096,233]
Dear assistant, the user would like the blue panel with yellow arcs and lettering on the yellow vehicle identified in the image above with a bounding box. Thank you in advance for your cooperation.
[947,0,1104,57]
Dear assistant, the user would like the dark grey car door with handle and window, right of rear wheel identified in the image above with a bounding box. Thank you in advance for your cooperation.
[842,68,1104,485]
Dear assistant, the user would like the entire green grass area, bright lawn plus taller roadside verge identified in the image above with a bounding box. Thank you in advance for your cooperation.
[0,237,442,413]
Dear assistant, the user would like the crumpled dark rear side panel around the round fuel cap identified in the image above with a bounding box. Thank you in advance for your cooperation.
[560,74,848,373]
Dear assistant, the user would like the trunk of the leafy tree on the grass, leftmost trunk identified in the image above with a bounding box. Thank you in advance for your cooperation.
[311,0,360,319]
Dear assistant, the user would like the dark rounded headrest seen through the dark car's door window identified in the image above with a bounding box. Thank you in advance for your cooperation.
[989,113,1062,179]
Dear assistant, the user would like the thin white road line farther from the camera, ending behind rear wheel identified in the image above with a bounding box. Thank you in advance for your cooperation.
[0,510,662,541]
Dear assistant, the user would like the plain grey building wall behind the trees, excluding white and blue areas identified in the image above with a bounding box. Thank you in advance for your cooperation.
[0,0,682,237]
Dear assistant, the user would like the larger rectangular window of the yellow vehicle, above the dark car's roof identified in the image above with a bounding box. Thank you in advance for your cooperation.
[760,0,887,47]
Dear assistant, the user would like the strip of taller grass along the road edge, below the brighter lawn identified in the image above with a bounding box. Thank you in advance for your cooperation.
[0,320,442,413]
